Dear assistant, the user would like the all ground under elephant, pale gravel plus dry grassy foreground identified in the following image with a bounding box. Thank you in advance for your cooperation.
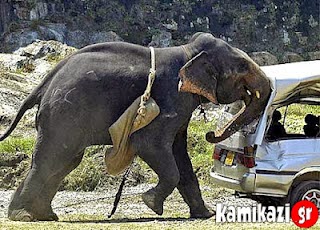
[0,184,310,230]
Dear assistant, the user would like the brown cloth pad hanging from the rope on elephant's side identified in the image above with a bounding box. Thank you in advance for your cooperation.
[104,96,160,175]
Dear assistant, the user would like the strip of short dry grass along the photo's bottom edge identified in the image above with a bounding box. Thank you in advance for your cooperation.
[0,215,319,230]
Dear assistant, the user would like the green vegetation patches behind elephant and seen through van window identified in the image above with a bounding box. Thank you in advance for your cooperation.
[0,104,320,191]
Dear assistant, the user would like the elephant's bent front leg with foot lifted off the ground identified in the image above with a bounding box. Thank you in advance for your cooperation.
[131,133,180,215]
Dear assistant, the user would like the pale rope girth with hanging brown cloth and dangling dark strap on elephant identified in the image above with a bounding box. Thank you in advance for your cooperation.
[105,47,160,218]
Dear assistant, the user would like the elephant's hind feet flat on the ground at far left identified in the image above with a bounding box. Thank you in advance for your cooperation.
[8,209,59,222]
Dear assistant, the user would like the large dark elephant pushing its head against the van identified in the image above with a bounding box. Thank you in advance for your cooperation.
[0,32,271,221]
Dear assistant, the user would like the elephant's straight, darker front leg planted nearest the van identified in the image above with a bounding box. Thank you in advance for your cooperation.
[173,126,214,218]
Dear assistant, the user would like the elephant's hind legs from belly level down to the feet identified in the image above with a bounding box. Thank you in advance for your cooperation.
[8,135,83,221]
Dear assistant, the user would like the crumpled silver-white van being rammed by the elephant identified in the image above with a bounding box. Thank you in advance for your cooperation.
[210,60,320,210]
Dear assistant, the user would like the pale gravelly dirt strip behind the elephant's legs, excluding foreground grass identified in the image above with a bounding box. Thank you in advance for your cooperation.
[0,184,254,218]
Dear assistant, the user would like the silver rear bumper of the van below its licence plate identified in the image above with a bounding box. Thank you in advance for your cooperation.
[210,167,256,193]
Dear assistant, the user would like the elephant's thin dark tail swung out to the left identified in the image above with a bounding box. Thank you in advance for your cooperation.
[0,89,38,141]
